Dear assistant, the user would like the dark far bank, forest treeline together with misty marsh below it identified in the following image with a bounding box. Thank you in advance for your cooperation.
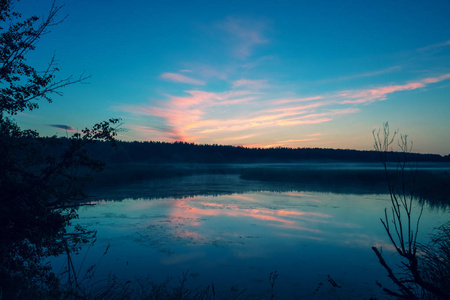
[51,138,444,205]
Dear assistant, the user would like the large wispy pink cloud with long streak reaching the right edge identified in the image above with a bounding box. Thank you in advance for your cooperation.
[120,74,450,147]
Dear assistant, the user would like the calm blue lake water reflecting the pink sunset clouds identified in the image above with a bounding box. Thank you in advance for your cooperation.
[56,175,448,299]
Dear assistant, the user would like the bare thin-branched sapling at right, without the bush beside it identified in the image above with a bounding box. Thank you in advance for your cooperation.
[372,123,450,299]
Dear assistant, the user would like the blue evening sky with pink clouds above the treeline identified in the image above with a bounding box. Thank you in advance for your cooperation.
[15,0,450,155]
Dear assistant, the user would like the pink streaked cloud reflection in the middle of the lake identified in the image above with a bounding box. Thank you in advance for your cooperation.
[168,193,332,244]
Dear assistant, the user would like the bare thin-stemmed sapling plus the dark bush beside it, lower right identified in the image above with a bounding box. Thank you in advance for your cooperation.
[372,123,450,299]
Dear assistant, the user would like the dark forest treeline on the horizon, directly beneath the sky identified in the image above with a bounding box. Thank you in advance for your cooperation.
[51,138,450,164]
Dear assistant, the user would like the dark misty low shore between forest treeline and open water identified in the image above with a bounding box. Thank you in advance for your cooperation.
[91,163,450,206]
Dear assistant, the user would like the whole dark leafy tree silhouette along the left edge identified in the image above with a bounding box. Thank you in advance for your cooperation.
[0,0,120,299]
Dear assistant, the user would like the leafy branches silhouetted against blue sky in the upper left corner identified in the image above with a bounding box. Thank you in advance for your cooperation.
[0,0,90,118]
